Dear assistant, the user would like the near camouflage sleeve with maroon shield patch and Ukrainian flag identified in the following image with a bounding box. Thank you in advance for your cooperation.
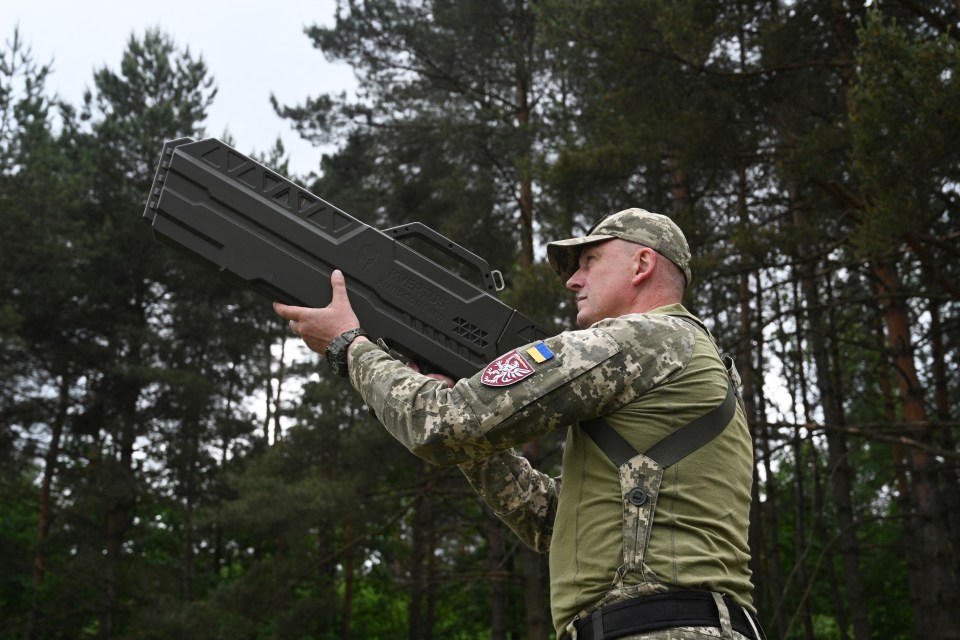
[349,314,695,464]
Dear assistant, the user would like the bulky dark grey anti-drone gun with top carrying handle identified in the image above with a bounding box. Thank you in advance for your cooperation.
[143,138,547,378]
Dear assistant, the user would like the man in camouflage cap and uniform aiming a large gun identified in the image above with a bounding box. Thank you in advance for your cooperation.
[275,209,762,639]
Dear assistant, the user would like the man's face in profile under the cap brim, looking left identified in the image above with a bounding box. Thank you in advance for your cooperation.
[567,238,639,329]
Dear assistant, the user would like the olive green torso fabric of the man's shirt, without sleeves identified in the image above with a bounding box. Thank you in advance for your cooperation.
[550,308,753,631]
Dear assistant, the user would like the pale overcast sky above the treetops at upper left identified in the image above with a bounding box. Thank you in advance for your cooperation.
[8,0,354,175]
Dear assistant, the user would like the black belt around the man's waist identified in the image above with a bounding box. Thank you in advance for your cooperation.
[574,591,765,640]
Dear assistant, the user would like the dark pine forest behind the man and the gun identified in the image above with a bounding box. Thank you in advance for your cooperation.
[0,0,960,640]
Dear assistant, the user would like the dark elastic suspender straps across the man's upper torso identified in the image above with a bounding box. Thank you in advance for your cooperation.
[580,316,737,469]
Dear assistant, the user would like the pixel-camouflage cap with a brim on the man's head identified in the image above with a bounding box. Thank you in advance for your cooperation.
[547,208,692,285]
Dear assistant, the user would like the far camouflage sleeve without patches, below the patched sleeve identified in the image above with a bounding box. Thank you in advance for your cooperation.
[460,450,560,553]
